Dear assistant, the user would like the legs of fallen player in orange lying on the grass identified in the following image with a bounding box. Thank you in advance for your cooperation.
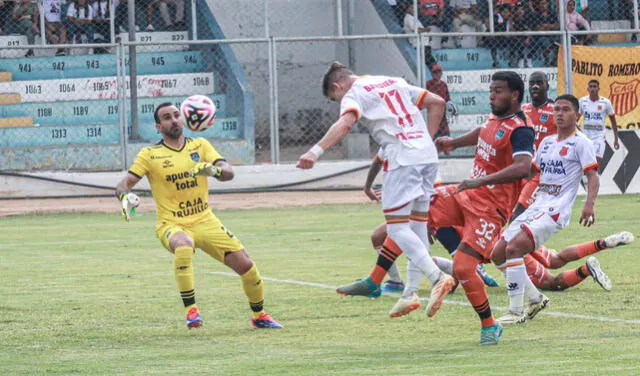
[524,231,635,291]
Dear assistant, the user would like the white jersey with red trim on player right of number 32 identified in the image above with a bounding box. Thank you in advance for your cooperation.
[532,130,598,223]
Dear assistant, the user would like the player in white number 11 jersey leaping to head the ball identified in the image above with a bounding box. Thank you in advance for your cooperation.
[297,62,455,317]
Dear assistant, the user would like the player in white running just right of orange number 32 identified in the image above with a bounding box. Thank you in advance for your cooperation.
[491,94,600,324]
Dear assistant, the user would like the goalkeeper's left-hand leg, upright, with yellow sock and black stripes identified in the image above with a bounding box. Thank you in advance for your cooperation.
[156,224,202,329]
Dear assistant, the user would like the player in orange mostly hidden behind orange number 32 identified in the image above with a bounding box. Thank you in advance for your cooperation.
[511,72,556,219]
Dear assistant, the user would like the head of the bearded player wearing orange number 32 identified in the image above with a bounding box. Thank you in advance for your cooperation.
[489,71,524,116]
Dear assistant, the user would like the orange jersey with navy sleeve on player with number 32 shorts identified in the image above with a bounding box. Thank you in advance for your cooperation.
[461,111,534,222]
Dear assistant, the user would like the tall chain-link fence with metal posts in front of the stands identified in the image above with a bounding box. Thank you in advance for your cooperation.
[0,0,640,170]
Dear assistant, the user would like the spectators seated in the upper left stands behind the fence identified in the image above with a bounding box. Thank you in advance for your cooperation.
[0,0,186,56]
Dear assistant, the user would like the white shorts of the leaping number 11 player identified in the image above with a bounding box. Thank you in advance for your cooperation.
[382,163,438,215]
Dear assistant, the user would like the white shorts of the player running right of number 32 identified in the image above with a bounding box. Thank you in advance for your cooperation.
[502,206,566,249]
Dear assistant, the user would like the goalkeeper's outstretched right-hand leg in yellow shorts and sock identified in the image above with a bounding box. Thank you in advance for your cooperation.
[193,218,283,329]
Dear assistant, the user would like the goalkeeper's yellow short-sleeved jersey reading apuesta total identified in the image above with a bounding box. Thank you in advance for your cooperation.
[129,138,224,225]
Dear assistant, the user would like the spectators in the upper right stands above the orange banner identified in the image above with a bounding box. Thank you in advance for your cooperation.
[388,0,633,68]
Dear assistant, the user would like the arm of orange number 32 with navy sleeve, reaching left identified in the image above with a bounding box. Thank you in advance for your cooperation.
[456,127,535,192]
